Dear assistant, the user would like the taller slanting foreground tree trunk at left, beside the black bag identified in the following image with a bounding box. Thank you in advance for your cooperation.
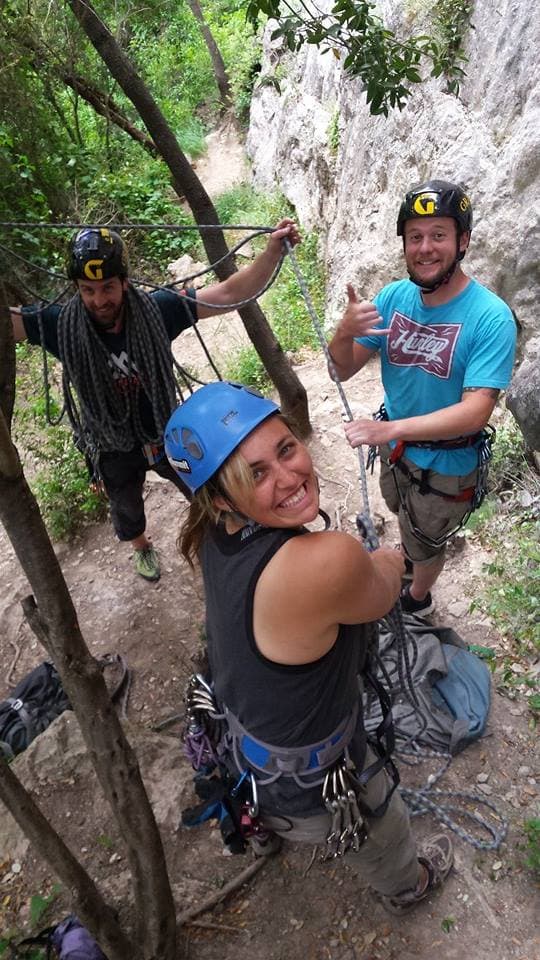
[0,296,176,960]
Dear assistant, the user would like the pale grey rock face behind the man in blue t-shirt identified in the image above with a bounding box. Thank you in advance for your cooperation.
[248,0,540,352]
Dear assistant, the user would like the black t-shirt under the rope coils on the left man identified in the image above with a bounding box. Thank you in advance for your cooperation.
[22,288,197,439]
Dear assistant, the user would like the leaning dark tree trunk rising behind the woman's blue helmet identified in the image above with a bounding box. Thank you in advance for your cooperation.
[65,0,310,435]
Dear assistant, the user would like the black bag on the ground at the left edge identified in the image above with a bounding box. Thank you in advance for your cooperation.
[0,661,71,759]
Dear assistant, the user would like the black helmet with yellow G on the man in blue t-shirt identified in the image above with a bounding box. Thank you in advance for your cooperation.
[397,180,472,237]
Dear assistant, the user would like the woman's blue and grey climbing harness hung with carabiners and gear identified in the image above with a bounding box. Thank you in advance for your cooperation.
[182,667,399,859]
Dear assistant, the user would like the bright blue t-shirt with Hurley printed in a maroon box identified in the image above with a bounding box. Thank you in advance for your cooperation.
[357,280,516,476]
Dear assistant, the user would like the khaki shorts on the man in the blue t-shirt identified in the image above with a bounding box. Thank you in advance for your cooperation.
[379,444,477,564]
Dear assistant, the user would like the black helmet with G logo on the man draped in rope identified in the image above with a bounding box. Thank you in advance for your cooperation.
[67,227,129,280]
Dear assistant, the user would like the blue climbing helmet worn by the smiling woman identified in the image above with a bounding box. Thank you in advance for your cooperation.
[164,380,279,493]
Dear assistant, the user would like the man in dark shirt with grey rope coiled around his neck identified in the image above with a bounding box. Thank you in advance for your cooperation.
[11,219,300,580]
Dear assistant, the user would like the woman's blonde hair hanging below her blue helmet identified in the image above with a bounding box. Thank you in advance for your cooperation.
[177,413,299,567]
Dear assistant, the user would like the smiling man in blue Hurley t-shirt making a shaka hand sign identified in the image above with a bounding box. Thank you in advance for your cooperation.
[330,180,516,616]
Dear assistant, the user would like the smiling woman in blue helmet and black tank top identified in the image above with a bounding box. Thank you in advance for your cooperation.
[165,382,452,913]
